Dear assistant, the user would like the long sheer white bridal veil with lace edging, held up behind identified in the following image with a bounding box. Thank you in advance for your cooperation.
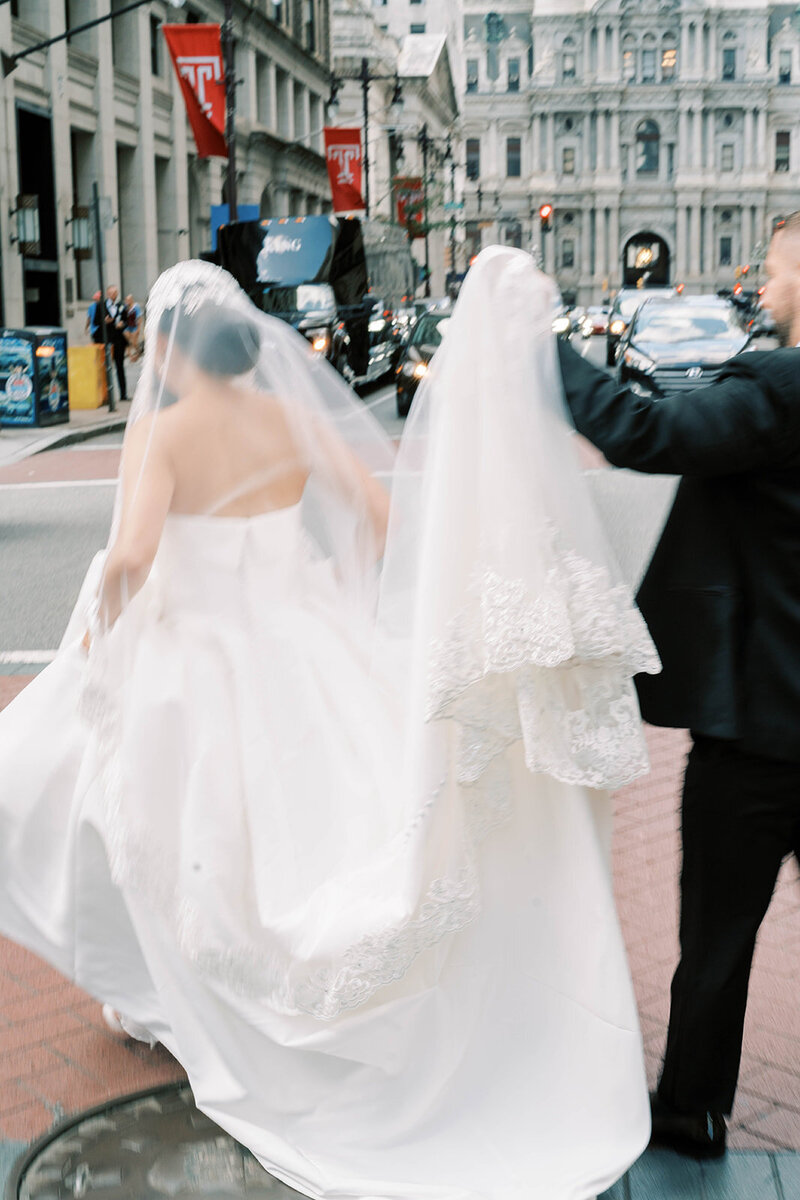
[68,247,657,1020]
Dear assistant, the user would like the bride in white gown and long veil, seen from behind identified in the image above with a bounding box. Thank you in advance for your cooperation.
[0,247,657,1200]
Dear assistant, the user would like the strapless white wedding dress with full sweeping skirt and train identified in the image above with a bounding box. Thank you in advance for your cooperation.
[0,253,649,1200]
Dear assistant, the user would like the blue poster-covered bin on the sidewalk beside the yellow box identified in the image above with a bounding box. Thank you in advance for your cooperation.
[0,325,70,425]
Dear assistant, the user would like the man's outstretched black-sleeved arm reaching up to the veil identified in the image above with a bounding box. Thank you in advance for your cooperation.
[558,340,800,475]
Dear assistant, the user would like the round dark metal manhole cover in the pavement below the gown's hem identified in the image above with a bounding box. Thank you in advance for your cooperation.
[12,1085,305,1200]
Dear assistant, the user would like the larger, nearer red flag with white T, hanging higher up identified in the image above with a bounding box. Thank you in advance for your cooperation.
[162,25,228,158]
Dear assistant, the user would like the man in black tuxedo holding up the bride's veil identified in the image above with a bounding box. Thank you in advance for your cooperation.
[558,212,800,1157]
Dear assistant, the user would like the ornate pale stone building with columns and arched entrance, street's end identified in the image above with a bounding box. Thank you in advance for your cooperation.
[462,0,800,304]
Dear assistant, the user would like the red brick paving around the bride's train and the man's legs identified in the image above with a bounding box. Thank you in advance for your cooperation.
[0,676,800,1150]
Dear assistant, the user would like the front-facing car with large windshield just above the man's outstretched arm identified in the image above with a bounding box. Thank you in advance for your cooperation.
[616,296,750,396]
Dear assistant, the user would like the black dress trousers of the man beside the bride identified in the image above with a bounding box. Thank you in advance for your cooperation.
[658,736,800,1114]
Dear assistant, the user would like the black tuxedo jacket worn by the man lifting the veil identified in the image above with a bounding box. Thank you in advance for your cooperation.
[558,341,800,762]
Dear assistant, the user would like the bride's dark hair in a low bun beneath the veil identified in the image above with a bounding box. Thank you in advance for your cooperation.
[158,302,260,378]
